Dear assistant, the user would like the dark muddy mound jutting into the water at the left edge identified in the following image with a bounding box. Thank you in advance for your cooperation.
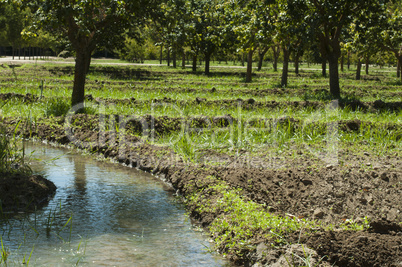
[0,173,56,216]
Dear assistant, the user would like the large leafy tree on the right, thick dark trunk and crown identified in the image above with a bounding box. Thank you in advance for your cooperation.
[304,0,387,98]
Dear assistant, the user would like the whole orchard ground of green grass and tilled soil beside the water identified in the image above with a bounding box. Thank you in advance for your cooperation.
[0,60,402,265]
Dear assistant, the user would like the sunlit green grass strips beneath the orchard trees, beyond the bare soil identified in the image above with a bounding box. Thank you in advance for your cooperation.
[0,63,402,161]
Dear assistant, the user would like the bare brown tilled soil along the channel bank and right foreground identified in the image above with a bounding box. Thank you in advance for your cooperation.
[4,115,402,266]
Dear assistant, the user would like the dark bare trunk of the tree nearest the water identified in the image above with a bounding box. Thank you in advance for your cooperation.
[71,49,91,106]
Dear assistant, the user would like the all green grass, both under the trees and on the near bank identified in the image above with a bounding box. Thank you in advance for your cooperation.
[0,60,402,265]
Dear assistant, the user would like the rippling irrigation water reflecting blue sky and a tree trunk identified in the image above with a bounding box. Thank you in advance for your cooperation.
[0,143,228,266]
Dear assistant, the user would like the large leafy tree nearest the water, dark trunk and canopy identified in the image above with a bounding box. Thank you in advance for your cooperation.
[23,0,157,108]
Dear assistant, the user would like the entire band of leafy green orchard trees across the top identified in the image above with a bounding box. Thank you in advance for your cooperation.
[0,0,402,103]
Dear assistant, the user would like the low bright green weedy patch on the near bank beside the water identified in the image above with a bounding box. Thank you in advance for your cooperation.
[187,177,369,260]
